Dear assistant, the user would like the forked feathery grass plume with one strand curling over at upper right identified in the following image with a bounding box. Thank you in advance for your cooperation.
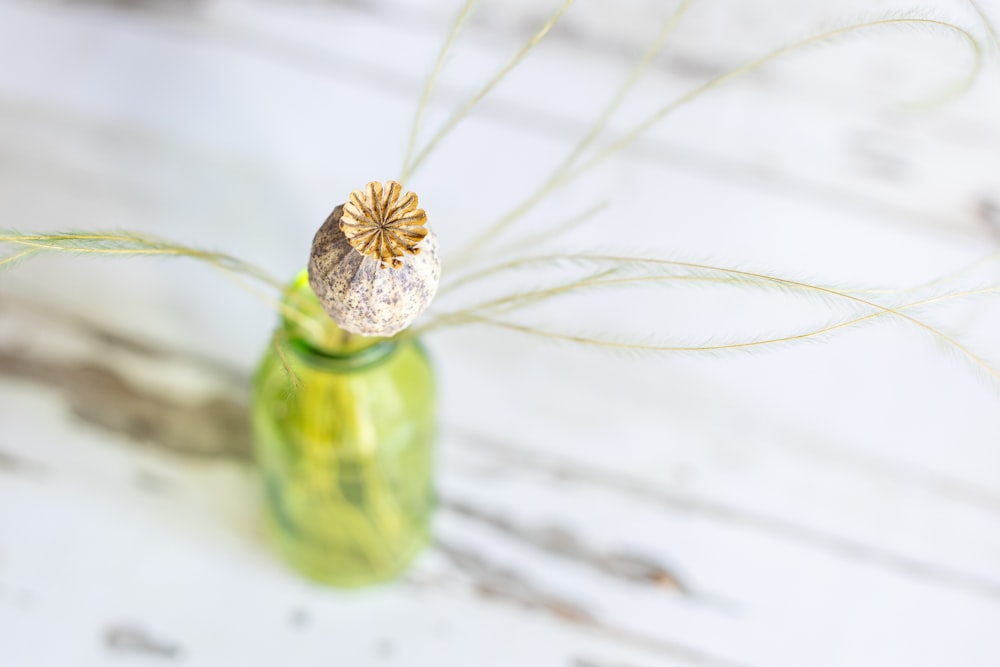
[459,13,983,263]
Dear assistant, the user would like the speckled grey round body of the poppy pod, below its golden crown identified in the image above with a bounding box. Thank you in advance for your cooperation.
[309,206,441,336]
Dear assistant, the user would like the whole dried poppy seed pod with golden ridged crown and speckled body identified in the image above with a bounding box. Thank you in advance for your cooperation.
[309,181,441,336]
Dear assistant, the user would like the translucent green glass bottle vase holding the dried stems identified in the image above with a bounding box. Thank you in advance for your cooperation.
[252,271,435,587]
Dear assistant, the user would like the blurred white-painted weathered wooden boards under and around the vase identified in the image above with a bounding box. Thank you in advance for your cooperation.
[0,0,1000,667]
